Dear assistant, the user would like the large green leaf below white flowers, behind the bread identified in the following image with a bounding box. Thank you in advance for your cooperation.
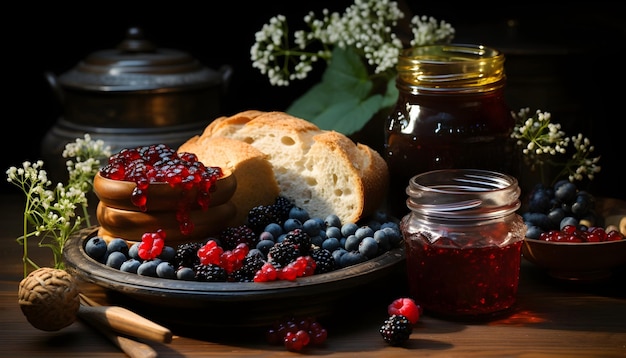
[286,48,397,135]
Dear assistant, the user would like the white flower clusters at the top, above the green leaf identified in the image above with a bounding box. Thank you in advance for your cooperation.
[250,0,454,86]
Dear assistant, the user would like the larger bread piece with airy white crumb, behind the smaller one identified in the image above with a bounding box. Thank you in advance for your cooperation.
[197,111,389,223]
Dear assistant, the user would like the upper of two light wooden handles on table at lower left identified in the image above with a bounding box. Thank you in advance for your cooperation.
[78,304,172,343]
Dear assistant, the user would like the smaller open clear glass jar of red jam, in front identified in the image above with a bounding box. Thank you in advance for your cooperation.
[400,169,526,319]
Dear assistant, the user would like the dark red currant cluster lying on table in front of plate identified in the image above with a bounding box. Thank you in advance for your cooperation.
[266,317,328,351]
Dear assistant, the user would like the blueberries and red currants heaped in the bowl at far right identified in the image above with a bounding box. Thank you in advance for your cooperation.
[522,180,624,242]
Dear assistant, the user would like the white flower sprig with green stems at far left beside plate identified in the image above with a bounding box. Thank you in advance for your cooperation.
[6,134,111,277]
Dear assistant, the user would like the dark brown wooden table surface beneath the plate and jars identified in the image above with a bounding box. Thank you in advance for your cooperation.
[0,194,626,358]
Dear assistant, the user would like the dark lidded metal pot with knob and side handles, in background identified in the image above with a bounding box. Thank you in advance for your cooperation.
[47,28,232,128]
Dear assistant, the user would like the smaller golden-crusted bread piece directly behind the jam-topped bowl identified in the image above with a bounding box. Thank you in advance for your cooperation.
[178,135,280,227]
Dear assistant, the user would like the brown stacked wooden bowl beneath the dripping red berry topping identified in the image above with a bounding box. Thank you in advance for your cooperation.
[94,172,237,246]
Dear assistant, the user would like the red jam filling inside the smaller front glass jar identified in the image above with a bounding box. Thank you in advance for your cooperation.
[406,229,522,316]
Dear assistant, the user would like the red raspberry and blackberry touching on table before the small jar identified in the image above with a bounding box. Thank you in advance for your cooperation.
[379,297,422,346]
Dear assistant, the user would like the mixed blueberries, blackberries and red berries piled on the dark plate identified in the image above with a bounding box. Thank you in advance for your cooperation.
[85,196,402,282]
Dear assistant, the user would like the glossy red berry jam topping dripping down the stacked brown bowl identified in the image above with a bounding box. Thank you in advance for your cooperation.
[100,144,223,235]
